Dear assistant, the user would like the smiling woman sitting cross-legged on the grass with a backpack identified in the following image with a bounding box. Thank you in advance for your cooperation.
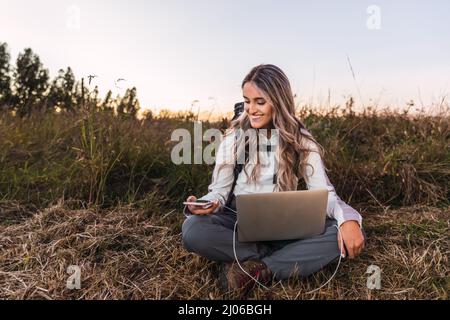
[182,65,364,292]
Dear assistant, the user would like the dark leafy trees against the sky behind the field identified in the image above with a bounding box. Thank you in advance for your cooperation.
[0,42,140,117]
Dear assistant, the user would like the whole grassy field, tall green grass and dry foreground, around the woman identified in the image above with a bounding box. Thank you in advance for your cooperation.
[0,108,450,299]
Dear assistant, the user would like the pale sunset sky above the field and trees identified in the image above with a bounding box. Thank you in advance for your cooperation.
[0,0,450,112]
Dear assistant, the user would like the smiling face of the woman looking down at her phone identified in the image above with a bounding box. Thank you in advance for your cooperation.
[243,82,273,129]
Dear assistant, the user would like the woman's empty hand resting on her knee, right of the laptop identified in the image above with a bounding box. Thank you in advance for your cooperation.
[338,220,364,259]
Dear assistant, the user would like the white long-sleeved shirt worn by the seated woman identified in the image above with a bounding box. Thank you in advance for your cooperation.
[184,130,362,226]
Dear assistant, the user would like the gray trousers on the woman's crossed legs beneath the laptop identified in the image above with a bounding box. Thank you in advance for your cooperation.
[182,210,340,280]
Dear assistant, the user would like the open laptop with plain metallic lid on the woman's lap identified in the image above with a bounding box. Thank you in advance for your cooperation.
[236,189,328,242]
